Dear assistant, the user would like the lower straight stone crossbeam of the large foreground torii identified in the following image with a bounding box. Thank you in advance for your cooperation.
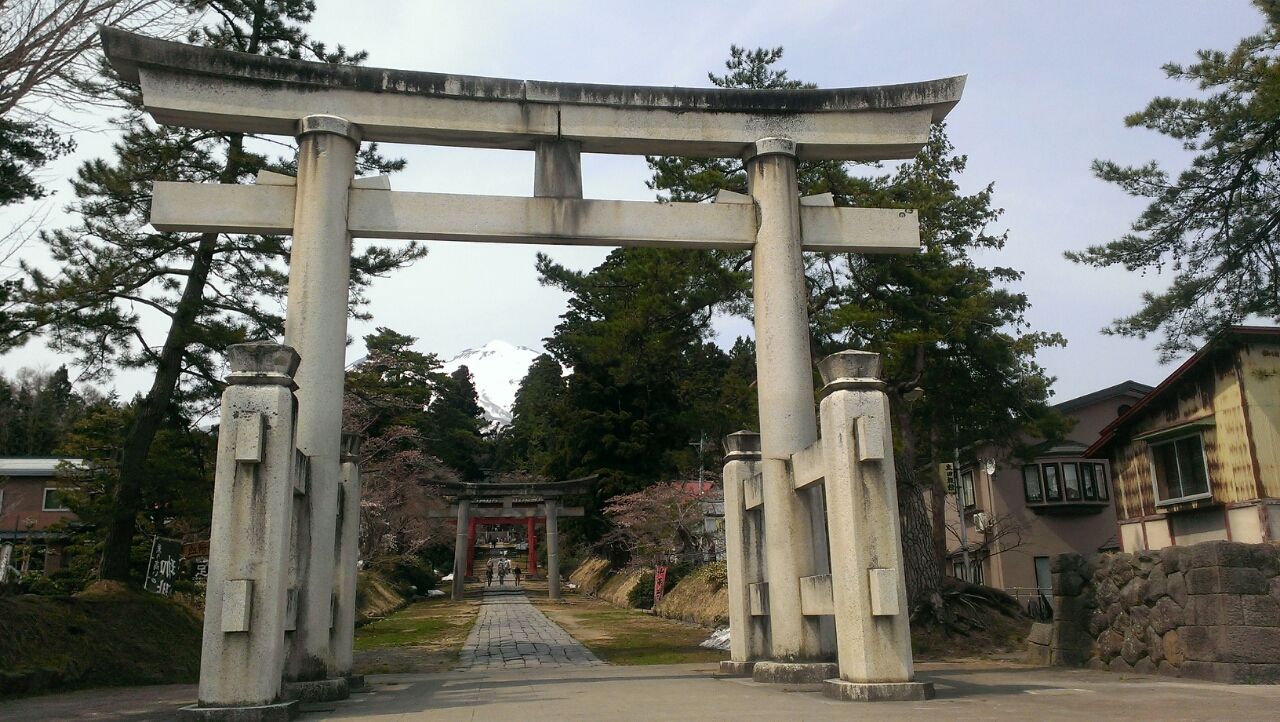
[150,182,920,253]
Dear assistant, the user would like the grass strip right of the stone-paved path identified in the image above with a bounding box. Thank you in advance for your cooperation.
[532,594,728,664]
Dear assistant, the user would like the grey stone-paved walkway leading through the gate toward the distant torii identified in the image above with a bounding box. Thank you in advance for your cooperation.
[458,584,604,670]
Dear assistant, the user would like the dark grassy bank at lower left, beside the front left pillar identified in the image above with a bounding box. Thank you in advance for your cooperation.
[0,589,201,696]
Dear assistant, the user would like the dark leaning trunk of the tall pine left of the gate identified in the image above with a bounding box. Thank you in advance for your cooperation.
[97,136,243,581]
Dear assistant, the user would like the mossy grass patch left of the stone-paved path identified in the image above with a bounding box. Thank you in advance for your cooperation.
[355,597,479,675]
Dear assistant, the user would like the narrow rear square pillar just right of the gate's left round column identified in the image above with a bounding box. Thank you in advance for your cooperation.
[330,434,360,680]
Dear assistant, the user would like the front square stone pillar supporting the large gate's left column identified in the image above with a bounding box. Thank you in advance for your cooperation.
[182,343,298,719]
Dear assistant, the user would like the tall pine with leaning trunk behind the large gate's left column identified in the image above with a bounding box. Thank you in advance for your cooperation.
[6,0,425,580]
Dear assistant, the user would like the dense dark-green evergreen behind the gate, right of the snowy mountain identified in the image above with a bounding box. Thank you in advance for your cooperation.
[512,248,749,540]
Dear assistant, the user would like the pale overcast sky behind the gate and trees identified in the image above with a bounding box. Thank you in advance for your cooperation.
[0,0,1262,401]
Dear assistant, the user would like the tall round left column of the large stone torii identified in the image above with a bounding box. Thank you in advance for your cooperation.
[284,115,360,696]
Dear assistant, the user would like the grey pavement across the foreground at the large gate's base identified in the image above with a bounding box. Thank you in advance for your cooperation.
[0,662,1280,722]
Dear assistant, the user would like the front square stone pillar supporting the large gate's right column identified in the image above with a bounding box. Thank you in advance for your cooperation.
[818,351,933,700]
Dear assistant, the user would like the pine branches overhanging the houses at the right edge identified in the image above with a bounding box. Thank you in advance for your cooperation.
[1066,0,1280,361]
